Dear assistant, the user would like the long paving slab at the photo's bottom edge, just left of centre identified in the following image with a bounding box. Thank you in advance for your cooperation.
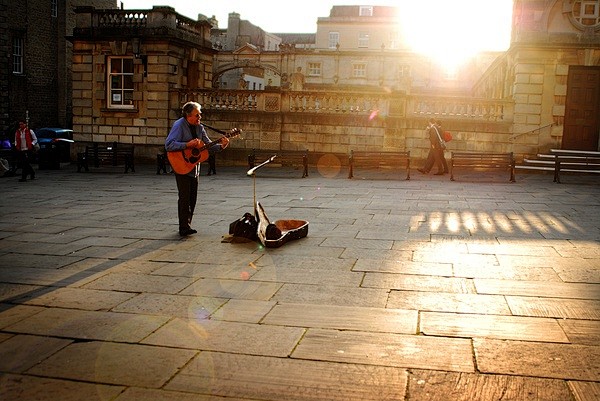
[166,352,407,401]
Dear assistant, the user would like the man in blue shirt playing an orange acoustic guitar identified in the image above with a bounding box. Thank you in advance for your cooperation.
[165,102,229,237]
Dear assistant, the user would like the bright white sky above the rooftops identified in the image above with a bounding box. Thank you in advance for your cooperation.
[117,0,513,64]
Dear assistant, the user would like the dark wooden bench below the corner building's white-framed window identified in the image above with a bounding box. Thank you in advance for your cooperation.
[77,142,135,173]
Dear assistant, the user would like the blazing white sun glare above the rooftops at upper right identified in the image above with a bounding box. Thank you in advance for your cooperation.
[400,0,512,69]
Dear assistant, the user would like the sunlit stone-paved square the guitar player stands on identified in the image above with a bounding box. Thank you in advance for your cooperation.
[0,162,600,401]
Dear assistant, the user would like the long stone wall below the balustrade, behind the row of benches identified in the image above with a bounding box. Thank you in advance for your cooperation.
[202,106,523,164]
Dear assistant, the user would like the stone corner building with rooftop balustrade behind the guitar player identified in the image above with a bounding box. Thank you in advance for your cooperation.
[71,7,216,157]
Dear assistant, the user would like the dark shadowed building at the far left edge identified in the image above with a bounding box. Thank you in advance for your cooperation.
[0,0,116,135]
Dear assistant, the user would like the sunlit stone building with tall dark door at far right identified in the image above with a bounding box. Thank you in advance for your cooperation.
[473,0,600,155]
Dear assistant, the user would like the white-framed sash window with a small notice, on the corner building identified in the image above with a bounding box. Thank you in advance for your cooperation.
[108,57,133,109]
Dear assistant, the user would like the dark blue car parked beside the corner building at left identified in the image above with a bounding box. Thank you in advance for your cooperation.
[34,128,73,169]
